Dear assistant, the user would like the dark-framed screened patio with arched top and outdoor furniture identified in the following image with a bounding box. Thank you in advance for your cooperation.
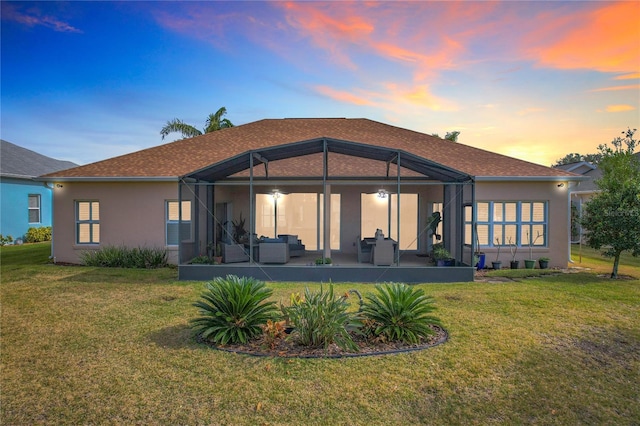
[177,138,476,283]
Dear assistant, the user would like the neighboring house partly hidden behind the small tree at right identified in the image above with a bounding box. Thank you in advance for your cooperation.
[555,152,640,243]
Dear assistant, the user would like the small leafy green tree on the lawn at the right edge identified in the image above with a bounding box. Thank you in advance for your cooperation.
[581,129,640,278]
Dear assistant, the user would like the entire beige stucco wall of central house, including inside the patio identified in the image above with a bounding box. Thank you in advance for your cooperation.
[53,178,569,267]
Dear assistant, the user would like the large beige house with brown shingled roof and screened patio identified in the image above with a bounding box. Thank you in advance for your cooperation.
[41,118,582,282]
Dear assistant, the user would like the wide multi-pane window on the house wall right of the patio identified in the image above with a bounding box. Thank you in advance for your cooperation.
[465,201,547,247]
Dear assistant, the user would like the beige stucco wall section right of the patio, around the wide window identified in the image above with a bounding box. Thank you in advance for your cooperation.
[476,182,569,268]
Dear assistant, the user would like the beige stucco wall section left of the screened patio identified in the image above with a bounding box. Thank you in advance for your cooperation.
[53,182,178,263]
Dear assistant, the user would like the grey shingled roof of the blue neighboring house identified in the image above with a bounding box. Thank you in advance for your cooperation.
[0,139,77,179]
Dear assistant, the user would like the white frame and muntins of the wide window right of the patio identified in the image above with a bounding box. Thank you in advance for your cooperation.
[465,200,549,248]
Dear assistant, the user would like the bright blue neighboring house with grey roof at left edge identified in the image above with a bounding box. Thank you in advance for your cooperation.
[0,140,77,240]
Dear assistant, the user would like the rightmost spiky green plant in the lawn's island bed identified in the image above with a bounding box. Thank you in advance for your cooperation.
[362,284,440,343]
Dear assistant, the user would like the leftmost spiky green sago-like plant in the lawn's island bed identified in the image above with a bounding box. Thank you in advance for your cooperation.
[191,275,277,345]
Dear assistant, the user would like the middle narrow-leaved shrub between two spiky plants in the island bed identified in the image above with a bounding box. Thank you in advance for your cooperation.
[285,285,359,352]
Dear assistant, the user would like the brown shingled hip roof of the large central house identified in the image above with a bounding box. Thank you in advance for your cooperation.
[43,118,576,180]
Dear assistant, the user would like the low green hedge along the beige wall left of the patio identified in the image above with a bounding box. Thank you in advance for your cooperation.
[80,246,167,269]
